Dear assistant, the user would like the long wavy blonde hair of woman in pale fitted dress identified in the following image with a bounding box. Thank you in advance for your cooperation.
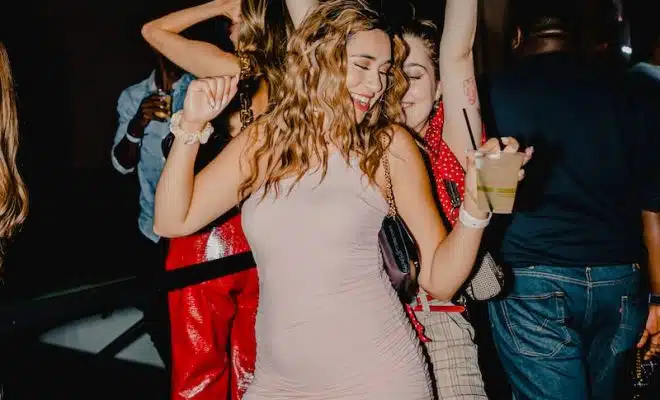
[239,0,408,198]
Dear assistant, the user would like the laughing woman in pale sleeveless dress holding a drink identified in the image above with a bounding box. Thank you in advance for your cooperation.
[154,0,528,400]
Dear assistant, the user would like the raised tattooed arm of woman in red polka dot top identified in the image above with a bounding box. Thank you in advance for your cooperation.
[440,0,482,169]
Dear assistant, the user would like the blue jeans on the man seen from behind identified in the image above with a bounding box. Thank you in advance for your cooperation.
[488,264,648,400]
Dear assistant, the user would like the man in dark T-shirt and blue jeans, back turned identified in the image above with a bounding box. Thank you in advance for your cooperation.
[484,1,660,400]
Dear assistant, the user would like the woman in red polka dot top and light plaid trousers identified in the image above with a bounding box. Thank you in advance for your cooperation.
[402,0,487,399]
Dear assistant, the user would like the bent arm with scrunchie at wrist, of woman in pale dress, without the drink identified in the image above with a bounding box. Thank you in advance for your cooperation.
[154,77,258,237]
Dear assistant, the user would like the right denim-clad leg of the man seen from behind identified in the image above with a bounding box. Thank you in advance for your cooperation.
[587,264,648,400]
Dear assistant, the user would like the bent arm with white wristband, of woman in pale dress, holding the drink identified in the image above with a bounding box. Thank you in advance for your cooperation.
[390,129,486,300]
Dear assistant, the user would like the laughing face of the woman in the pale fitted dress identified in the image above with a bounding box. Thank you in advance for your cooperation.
[346,29,392,123]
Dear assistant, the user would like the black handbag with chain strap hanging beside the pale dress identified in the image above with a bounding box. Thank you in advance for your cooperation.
[378,154,419,304]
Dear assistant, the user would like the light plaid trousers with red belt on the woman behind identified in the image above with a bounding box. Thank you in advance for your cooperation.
[415,292,488,400]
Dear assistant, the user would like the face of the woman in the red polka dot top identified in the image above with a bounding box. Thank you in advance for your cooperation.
[401,35,442,133]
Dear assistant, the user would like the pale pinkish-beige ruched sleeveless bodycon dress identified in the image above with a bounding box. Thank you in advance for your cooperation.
[242,153,432,400]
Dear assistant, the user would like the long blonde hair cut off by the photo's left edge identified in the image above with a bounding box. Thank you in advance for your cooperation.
[0,42,28,269]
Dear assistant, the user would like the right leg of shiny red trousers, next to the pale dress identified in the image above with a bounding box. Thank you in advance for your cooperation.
[230,268,259,400]
